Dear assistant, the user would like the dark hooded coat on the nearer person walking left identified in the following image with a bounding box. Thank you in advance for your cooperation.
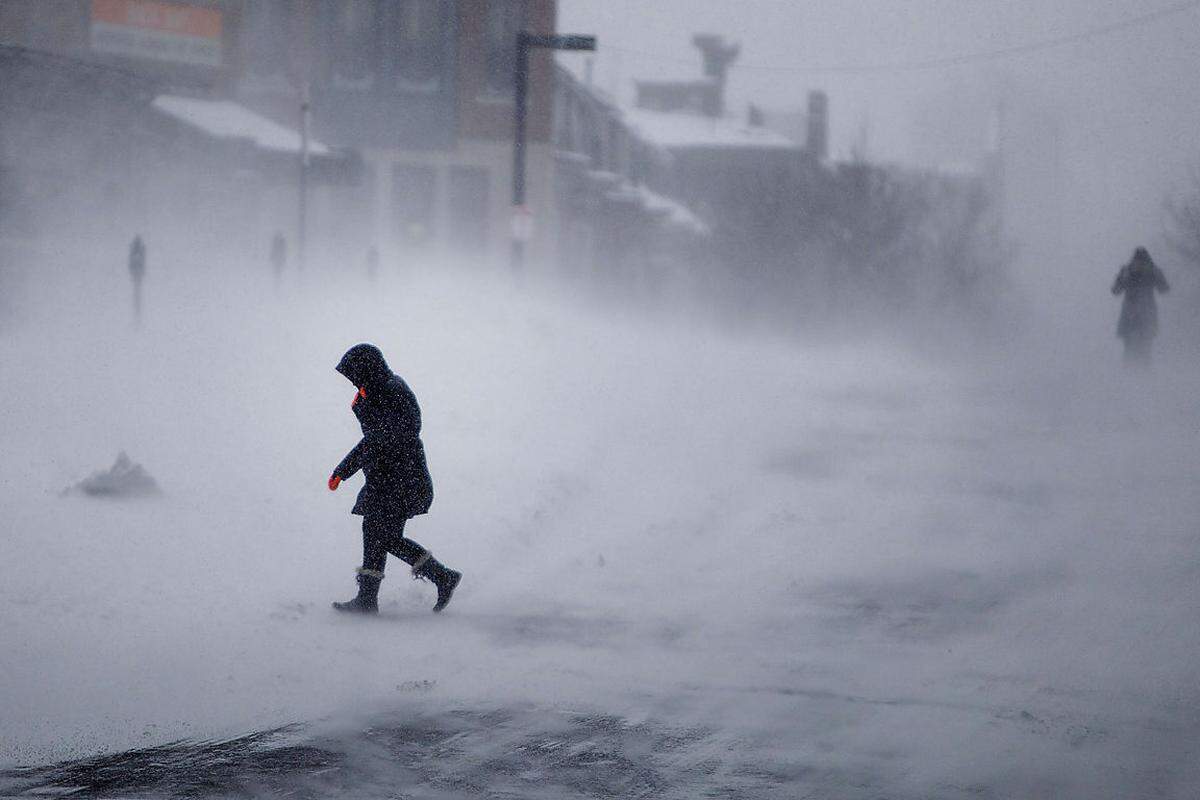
[334,344,433,519]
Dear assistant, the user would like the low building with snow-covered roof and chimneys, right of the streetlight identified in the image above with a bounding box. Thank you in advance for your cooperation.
[554,35,827,307]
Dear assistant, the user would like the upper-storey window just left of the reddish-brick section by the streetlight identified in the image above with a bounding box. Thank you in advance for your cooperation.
[379,0,446,91]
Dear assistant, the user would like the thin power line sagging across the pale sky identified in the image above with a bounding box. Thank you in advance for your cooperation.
[601,0,1200,74]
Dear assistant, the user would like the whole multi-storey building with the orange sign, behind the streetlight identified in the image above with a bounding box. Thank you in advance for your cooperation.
[0,0,556,271]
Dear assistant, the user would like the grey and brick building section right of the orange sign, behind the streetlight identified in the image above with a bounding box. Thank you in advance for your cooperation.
[236,0,556,268]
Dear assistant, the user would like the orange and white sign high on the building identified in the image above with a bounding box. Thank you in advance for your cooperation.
[91,0,222,67]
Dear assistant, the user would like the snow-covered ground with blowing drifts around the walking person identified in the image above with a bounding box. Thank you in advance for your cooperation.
[0,242,1200,799]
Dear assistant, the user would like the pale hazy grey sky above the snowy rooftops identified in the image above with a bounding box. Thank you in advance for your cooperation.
[559,0,1200,309]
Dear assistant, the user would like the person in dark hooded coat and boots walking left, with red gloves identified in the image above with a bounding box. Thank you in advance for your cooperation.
[329,344,462,614]
